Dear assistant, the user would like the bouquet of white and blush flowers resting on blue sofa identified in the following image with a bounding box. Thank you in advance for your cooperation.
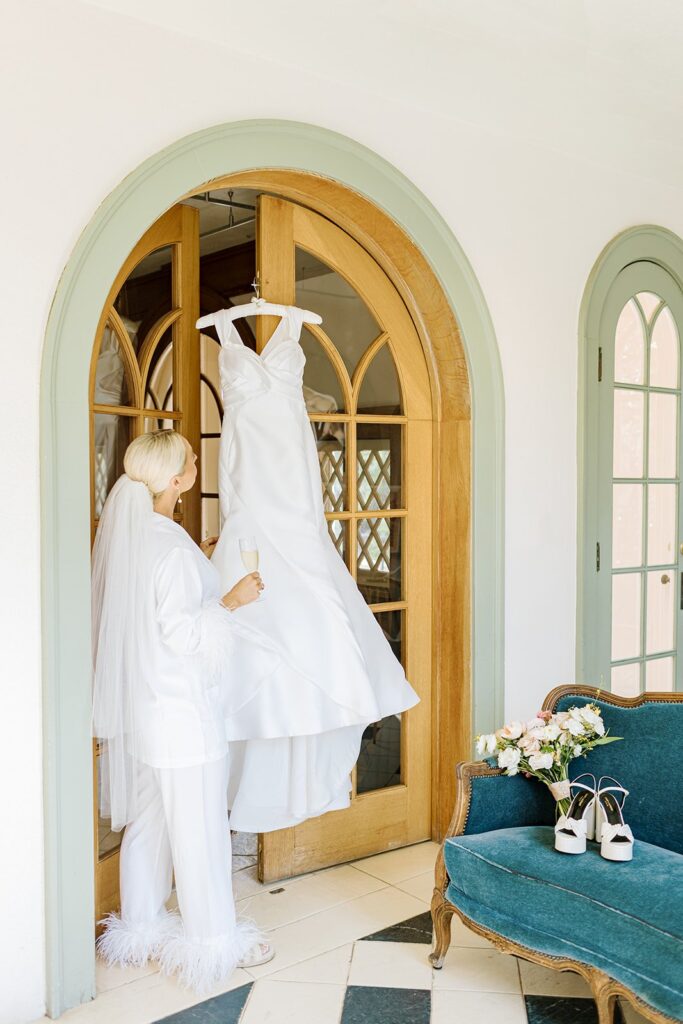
[476,705,623,814]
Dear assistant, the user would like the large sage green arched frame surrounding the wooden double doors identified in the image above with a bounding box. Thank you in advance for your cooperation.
[41,120,505,1016]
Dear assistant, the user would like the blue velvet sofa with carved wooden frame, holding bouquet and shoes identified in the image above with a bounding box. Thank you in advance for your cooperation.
[430,686,683,1024]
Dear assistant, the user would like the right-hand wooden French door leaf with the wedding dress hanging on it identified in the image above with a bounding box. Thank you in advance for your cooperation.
[256,196,433,881]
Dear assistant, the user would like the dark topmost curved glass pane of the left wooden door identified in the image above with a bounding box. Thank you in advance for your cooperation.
[114,246,174,353]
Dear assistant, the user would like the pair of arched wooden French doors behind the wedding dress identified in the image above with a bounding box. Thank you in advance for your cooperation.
[90,195,434,918]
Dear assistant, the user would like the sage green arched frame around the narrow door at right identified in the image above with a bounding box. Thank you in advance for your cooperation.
[577,224,683,689]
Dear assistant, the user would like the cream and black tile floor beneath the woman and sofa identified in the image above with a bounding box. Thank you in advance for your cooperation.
[33,837,643,1024]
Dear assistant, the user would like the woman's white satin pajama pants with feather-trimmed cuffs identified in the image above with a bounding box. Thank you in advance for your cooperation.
[97,757,263,992]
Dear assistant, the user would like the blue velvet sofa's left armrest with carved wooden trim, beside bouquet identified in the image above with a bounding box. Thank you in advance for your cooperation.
[435,761,555,893]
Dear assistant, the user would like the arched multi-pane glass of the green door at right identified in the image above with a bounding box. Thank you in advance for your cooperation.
[610,280,681,696]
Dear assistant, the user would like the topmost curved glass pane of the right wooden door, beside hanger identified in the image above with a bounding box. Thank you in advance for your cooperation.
[296,249,381,380]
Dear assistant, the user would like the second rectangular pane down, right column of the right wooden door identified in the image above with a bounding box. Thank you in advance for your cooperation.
[356,516,402,604]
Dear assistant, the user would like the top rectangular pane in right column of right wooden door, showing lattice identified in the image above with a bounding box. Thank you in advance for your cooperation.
[356,423,402,512]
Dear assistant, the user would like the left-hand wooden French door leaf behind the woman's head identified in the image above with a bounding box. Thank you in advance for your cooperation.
[90,206,200,920]
